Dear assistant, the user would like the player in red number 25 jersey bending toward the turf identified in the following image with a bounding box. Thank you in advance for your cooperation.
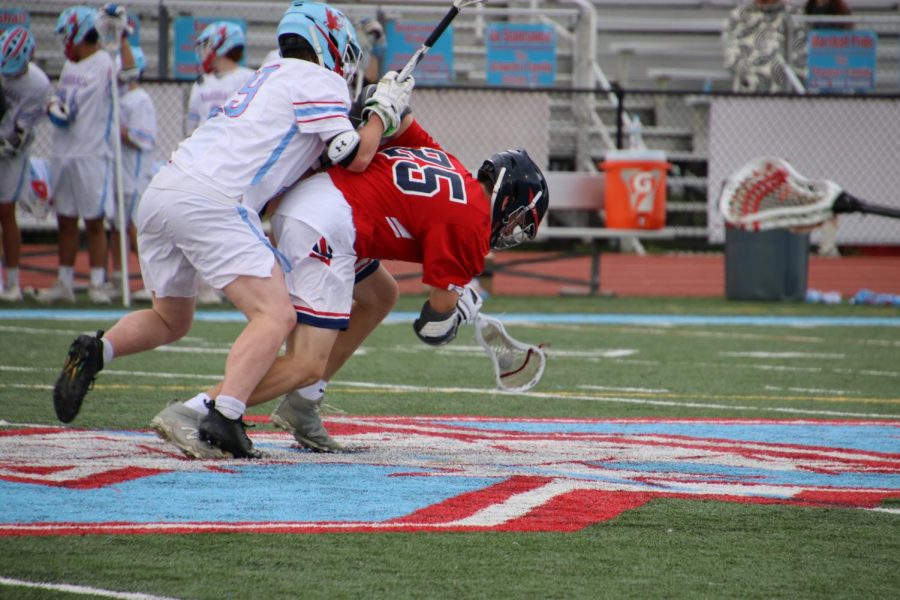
[158,105,549,458]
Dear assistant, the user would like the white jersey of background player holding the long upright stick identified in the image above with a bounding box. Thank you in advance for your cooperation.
[53,50,113,158]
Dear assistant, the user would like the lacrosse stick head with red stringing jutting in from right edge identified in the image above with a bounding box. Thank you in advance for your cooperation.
[719,158,900,231]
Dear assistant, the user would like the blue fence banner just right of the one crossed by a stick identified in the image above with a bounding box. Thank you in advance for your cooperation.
[487,24,556,86]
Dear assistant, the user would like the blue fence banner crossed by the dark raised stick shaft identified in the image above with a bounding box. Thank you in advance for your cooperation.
[386,21,453,85]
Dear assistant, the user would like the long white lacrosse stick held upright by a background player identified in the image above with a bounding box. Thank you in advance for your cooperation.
[96,4,131,308]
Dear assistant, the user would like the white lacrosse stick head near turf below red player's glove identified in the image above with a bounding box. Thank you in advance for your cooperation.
[475,313,547,392]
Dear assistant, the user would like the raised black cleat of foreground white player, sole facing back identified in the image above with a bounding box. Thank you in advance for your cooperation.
[53,331,103,423]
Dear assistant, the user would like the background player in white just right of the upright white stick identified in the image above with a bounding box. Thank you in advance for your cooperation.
[110,47,158,301]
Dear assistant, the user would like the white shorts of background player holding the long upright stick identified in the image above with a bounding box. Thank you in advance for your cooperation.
[50,156,115,219]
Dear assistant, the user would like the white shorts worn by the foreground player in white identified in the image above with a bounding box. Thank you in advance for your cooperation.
[137,166,290,298]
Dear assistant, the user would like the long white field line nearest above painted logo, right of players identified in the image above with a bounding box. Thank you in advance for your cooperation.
[333,381,897,419]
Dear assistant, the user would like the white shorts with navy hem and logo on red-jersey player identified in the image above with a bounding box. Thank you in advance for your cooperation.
[272,214,356,329]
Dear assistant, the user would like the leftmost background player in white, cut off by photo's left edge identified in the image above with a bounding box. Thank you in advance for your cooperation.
[0,27,51,302]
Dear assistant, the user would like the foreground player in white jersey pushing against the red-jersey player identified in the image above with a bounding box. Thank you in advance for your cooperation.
[53,1,413,458]
